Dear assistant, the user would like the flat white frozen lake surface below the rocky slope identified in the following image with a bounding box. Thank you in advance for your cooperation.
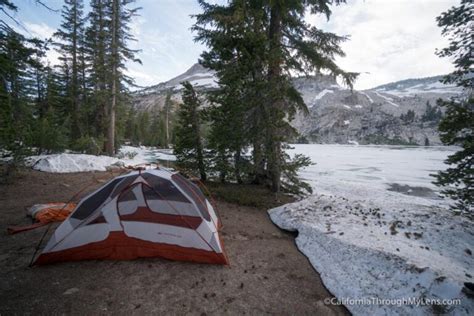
[289,144,455,202]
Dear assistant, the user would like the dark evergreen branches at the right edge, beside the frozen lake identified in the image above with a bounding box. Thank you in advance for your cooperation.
[435,0,474,212]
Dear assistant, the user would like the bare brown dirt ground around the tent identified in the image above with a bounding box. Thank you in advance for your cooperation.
[0,170,348,315]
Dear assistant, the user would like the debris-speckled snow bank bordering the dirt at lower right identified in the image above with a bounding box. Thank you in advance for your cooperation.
[269,194,474,315]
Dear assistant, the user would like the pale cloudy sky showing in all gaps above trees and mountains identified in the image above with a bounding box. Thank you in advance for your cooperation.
[5,0,459,90]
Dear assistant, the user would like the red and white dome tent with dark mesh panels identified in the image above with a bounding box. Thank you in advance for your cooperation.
[35,169,228,265]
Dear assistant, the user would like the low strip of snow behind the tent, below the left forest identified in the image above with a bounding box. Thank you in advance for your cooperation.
[26,146,176,173]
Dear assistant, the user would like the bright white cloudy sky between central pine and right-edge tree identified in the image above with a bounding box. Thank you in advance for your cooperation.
[308,0,458,89]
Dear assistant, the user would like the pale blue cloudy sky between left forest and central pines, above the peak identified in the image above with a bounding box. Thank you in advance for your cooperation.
[125,0,216,85]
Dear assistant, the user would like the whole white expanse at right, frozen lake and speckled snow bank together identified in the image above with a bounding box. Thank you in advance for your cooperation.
[269,145,474,315]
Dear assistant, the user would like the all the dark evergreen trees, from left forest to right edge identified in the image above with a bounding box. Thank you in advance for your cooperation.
[0,0,474,206]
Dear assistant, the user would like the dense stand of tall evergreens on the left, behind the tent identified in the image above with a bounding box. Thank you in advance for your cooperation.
[0,0,144,158]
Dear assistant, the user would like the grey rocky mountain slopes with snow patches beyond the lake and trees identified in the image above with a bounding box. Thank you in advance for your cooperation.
[134,64,461,145]
